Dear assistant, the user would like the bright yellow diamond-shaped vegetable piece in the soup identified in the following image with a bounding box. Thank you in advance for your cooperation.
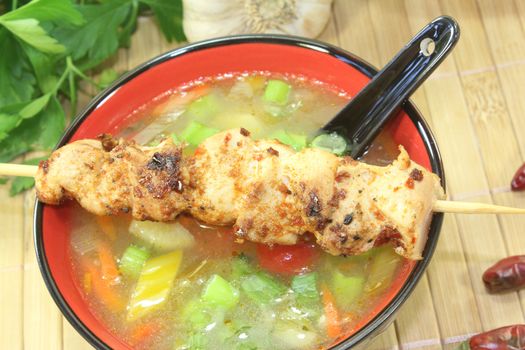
[127,250,182,321]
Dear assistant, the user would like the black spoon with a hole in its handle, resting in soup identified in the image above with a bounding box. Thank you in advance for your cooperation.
[322,16,459,158]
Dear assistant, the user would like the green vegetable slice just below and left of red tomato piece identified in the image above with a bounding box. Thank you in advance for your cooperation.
[241,273,286,305]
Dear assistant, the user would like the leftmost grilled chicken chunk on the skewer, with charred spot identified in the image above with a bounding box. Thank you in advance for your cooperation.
[35,136,188,221]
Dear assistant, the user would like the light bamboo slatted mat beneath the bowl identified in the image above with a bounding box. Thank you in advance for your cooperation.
[4,0,525,349]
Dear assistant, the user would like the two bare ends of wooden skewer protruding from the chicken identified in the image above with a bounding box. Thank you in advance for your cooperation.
[0,163,525,214]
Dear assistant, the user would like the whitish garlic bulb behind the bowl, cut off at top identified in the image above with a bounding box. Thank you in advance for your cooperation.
[183,0,332,42]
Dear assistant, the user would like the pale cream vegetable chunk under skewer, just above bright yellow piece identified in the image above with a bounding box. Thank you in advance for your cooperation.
[129,220,195,252]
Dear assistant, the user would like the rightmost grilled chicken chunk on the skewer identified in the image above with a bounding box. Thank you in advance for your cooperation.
[316,146,444,259]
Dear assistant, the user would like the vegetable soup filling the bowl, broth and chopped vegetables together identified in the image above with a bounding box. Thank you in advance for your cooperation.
[71,73,402,350]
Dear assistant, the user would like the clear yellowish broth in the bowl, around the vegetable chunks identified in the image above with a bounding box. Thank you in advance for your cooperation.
[71,72,403,350]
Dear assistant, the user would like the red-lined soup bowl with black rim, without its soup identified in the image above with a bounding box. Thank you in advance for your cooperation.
[34,35,444,349]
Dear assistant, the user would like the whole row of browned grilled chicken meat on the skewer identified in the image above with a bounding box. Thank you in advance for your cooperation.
[36,129,444,259]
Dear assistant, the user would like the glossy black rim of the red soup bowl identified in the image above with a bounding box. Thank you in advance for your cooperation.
[33,34,445,350]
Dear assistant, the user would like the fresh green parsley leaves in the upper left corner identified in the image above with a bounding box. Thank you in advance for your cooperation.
[0,0,185,195]
